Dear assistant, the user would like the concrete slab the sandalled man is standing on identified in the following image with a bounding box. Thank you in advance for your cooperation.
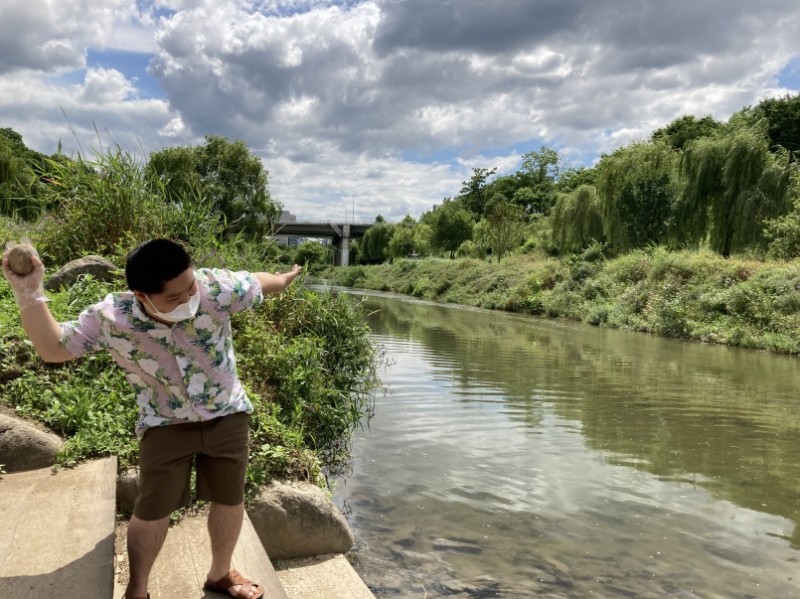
[114,510,289,599]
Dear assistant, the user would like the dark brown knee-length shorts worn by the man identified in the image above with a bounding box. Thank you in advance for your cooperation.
[133,412,250,520]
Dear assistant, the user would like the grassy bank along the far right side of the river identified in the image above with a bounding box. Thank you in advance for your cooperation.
[326,248,800,354]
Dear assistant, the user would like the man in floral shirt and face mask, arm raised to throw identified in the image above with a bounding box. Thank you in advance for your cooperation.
[3,239,300,599]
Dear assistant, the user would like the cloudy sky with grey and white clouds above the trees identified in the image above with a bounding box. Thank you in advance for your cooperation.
[0,0,800,222]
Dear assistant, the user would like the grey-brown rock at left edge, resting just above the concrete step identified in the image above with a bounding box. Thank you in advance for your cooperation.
[0,414,64,472]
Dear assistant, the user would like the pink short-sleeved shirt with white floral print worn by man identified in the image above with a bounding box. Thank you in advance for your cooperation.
[61,268,264,439]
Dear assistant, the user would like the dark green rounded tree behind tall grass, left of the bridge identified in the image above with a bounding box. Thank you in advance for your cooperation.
[146,135,281,238]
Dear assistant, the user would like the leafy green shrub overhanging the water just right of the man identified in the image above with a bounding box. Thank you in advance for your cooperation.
[234,283,379,473]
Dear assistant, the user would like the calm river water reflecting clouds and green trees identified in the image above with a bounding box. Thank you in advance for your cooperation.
[334,288,800,599]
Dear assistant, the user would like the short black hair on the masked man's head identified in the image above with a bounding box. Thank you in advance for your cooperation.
[125,239,192,293]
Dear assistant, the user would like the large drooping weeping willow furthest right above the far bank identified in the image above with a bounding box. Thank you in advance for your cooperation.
[673,121,791,257]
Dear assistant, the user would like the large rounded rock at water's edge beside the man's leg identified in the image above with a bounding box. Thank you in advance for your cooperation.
[247,482,353,559]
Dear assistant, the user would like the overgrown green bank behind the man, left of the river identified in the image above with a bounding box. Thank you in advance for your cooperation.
[0,140,379,491]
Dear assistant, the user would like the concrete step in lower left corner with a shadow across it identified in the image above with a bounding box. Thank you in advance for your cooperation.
[0,458,117,599]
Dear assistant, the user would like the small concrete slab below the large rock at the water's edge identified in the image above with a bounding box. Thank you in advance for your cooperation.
[275,555,375,599]
